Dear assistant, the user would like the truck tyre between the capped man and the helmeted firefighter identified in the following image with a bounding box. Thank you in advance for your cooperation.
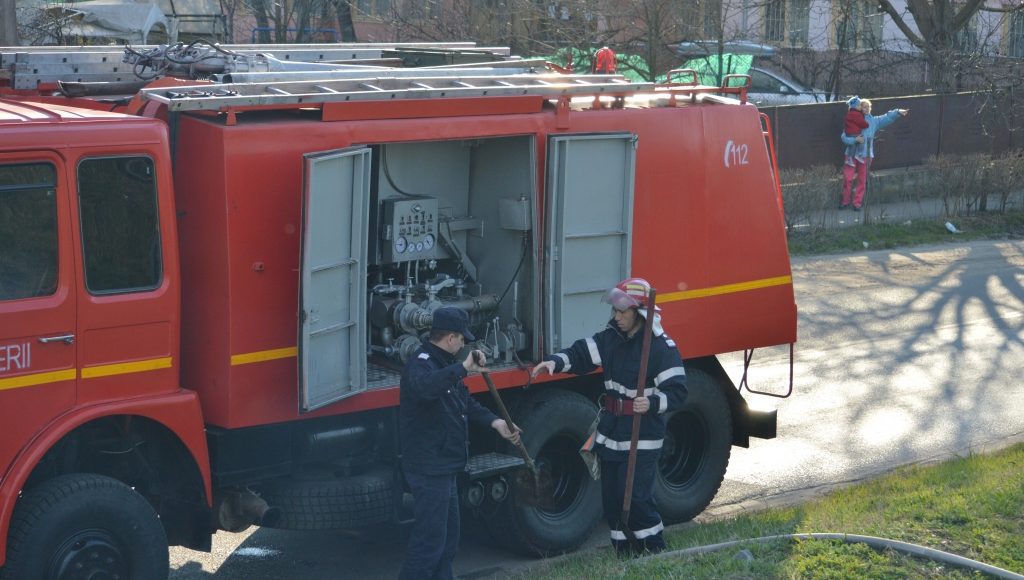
[485,388,601,556]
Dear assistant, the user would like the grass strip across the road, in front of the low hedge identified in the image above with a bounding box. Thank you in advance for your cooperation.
[790,210,1024,256]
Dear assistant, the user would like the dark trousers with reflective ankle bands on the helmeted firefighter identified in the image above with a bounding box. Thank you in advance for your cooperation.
[601,453,665,554]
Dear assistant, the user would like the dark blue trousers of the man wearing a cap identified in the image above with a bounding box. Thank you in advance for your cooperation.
[398,471,460,580]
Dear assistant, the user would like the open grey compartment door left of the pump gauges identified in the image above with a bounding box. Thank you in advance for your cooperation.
[299,148,371,413]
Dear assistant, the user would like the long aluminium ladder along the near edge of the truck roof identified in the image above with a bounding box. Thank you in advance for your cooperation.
[140,69,654,111]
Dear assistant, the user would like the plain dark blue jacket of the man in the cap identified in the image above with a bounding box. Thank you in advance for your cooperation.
[398,342,498,475]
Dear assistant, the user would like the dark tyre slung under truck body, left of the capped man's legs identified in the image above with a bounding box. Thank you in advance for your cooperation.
[261,469,394,530]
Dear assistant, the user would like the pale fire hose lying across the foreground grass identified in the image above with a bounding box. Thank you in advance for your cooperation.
[643,533,1024,580]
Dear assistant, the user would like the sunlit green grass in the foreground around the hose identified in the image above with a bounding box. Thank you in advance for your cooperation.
[514,445,1024,580]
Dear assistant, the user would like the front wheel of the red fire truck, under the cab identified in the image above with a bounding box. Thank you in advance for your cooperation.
[0,473,169,580]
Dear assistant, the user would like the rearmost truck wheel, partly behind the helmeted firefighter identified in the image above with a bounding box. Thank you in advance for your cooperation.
[654,369,732,524]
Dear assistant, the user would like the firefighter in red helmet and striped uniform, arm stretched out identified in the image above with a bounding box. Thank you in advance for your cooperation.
[532,278,686,555]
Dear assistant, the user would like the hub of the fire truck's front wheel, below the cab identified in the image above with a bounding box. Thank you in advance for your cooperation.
[48,530,129,580]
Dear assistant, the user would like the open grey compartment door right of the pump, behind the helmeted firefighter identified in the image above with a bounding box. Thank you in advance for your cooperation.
[545,134,636,351]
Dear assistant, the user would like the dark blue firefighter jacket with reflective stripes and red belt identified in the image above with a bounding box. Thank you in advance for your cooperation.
[547,322,686,461]
